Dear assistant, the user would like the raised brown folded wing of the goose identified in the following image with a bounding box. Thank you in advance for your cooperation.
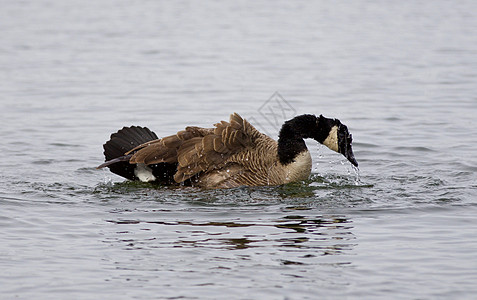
[127,113,262,182]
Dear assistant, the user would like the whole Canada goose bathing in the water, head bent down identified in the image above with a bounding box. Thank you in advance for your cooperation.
[98,113,358,188]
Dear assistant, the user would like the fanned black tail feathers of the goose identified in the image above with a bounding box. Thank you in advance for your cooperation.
[98,126,158,180]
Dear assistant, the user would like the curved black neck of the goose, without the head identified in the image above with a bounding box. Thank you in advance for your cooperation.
[278,115,317,165]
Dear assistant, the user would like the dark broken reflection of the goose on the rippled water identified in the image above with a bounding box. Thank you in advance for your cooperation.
[106,214,354,257]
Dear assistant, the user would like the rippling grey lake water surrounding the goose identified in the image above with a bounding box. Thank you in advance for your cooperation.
[0,0,477,299]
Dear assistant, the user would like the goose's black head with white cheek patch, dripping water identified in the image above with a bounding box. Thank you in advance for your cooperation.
[313,115,358,167]
